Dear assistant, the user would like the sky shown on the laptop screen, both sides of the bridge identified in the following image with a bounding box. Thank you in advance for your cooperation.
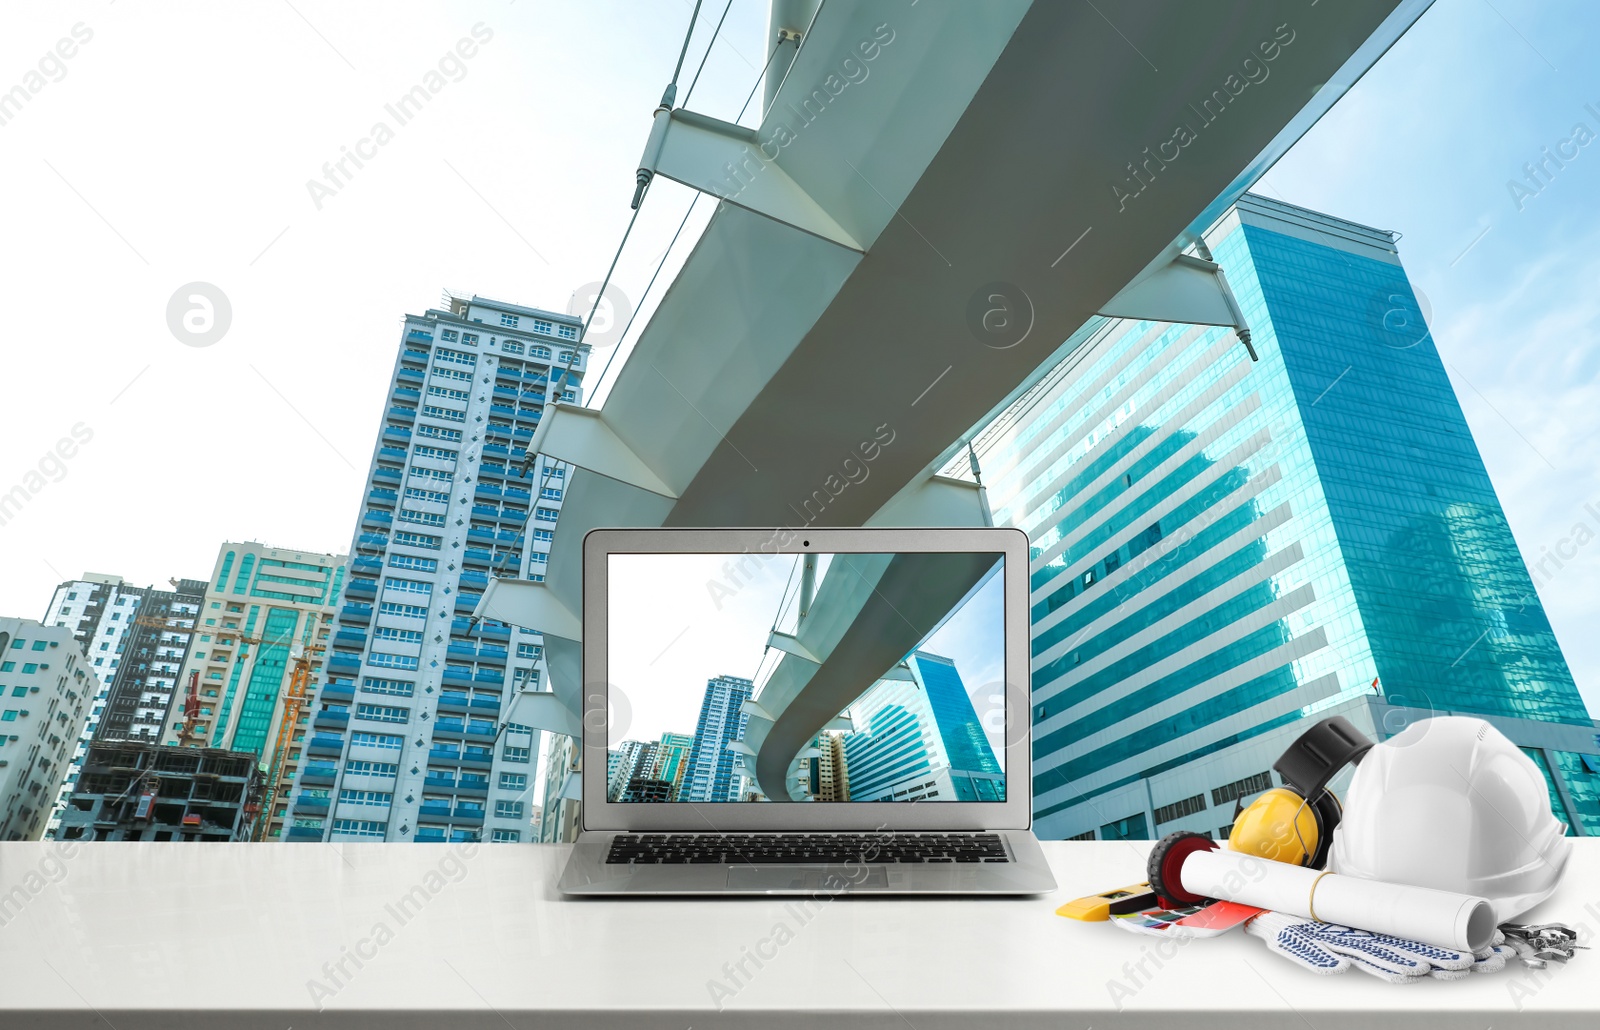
[606,555,1004,763]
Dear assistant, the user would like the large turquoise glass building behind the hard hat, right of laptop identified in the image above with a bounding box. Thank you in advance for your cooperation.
[960,197,1600,838]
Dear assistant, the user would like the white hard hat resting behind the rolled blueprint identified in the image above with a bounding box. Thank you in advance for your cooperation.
[1328,715,1571,923]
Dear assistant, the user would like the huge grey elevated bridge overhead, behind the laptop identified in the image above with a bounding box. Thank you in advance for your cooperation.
[478,0,1430,793]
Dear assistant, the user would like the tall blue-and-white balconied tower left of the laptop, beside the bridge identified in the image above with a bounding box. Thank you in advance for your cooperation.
[283,297,587,841]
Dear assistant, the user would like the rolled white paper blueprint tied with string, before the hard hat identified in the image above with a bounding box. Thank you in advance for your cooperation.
[1179,848,1494,952]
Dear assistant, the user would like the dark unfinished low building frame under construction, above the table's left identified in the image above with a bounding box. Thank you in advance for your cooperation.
[58,741,262,841]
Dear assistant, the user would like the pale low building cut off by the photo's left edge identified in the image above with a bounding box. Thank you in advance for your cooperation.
[0,619,99,841]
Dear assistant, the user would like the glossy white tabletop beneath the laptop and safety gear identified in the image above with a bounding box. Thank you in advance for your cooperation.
[0,840,1600,1030]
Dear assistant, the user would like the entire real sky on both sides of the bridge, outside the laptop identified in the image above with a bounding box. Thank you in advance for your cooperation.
[0,0,1600,712]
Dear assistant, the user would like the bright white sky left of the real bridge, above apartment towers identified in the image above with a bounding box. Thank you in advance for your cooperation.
[0,0,766,619]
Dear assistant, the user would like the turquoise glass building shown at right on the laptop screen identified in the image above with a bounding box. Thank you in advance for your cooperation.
[843,651,1005,801]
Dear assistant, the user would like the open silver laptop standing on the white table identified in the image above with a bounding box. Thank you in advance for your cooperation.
[558,528,1056,896]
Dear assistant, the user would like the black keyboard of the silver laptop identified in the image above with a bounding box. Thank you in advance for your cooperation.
[605,833,1011,865]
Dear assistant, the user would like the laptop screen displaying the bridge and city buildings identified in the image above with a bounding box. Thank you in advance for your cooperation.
[606,552,1004,803]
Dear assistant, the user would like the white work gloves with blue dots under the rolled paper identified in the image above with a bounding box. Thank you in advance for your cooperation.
[1245,912,1507,984]
